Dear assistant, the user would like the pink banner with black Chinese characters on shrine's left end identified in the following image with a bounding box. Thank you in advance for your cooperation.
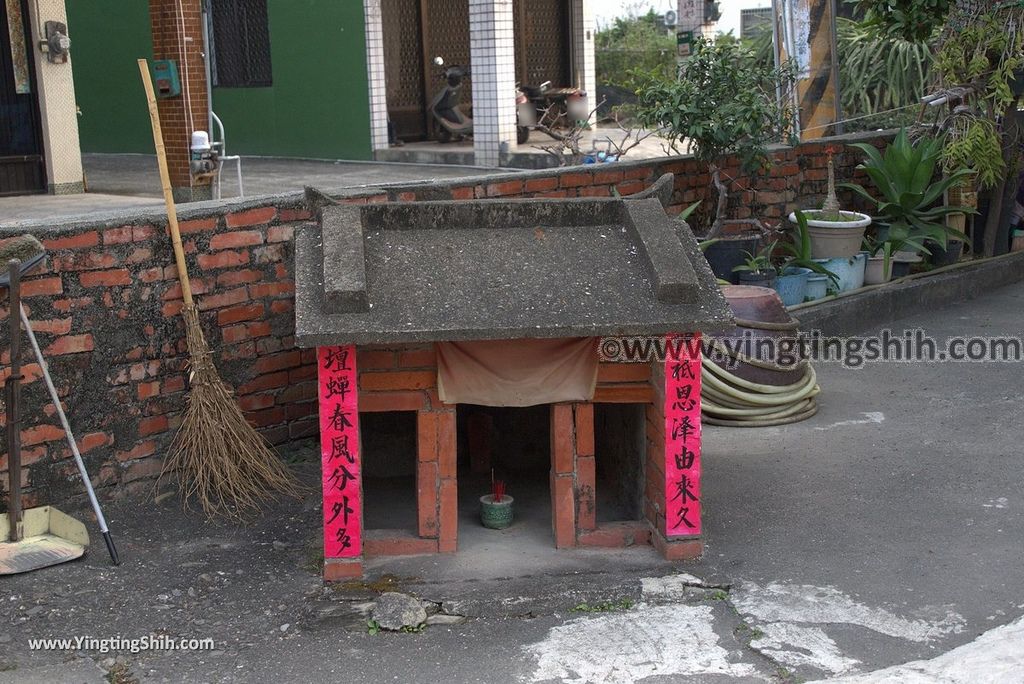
[316,345,362,558]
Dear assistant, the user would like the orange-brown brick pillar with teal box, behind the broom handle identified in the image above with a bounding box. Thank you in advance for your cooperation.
[150,0,211,202]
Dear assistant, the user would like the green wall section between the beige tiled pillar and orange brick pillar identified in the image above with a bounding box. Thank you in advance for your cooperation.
[67,0,153,154]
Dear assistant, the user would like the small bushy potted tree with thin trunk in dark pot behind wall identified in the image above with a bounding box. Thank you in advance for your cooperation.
[637,38,795,280]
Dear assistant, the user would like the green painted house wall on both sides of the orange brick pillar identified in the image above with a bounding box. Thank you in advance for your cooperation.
[67,0,371,159]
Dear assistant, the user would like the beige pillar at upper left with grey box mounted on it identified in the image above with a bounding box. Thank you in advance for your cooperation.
[28,0,85,195]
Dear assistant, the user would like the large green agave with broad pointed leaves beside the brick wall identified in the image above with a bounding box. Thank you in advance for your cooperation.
[841,129,974,248]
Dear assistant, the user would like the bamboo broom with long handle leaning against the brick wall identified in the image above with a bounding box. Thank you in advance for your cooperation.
[138,59,298,517]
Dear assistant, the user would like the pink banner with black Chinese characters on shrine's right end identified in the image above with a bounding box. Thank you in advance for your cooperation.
[665,334,700,538]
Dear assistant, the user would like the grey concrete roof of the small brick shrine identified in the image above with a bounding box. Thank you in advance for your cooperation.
[295,176,732,346]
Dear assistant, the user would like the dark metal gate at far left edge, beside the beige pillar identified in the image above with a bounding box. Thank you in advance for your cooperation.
[0,0,46,196]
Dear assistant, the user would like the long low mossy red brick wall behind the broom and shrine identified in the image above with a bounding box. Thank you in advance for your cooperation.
[0,136,885,506]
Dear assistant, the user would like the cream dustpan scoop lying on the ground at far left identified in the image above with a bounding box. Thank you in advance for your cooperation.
[0,506,89,574]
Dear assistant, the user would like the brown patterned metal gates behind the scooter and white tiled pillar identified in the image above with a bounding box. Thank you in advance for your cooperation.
[381,0,572,140]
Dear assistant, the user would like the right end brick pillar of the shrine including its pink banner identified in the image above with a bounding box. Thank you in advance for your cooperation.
[644,335,703,560]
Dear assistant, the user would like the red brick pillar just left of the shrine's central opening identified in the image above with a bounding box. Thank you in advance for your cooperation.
[416,408,459,553]
